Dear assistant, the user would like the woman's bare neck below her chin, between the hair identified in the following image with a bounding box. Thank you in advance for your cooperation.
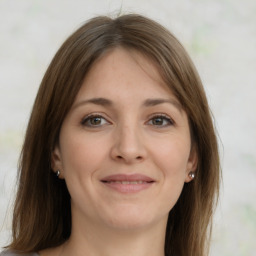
[61,212,166,256]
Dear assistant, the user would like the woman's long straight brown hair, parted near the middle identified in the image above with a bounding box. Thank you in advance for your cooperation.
[6,14,221,256]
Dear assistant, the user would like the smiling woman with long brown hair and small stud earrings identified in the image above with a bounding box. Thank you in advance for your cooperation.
[1,15,220,256]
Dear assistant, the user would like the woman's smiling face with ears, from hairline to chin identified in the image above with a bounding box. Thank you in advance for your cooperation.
[52,48,196,232]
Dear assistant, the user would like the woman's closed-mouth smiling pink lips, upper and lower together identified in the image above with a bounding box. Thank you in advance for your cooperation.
[101,174,155,193]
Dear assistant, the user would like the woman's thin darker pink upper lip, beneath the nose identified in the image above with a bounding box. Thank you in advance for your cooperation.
[101,174,155,182]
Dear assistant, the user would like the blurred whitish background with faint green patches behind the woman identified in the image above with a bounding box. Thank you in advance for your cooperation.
[0,0,256,256]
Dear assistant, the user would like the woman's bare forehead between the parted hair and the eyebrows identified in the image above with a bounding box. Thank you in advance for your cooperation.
[78,47,173,100]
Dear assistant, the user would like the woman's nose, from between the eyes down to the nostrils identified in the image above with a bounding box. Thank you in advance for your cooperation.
[111,125,146,164]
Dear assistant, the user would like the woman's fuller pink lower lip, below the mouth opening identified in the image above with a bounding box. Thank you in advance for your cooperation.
[103,182,154,193]
